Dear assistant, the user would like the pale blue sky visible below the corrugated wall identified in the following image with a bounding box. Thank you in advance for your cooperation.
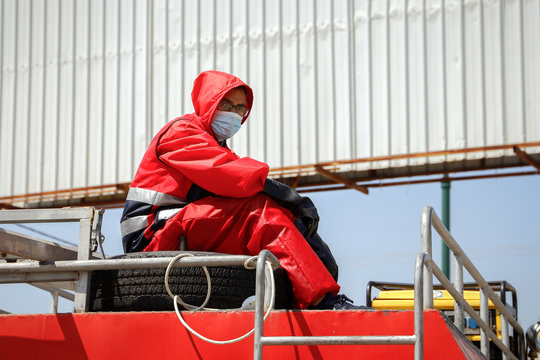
[0,170,540,330]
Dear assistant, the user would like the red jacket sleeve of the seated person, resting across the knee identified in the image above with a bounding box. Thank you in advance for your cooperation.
[156,121,268,198]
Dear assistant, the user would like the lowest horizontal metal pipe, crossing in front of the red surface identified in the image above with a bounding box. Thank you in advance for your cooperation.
[261,335,416,345]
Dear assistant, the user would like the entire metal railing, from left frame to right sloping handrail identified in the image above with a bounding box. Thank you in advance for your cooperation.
[0,206,525,360]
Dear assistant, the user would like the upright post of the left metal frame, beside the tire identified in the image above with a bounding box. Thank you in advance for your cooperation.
[75,216,93,313]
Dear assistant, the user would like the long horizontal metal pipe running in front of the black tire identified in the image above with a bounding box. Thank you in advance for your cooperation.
[0,255,279,279]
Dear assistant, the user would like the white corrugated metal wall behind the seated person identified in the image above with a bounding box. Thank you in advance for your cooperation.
[0,0,540,196]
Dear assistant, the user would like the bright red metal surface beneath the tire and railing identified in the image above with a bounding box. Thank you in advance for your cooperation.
[0,311,476,360]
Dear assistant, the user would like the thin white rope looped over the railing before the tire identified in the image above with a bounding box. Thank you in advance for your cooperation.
[165,253,276,345]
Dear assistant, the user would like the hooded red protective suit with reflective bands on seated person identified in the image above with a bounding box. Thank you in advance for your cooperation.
[121,71,339,308]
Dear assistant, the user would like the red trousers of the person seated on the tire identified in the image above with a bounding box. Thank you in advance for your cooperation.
[145,193,339,309]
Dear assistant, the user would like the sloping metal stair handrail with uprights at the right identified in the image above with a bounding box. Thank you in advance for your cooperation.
[421,206,524,359]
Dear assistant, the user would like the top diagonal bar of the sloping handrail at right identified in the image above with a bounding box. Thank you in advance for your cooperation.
[431,211,523,334]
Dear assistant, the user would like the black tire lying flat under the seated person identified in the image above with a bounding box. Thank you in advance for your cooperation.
[89,251,293,311]
